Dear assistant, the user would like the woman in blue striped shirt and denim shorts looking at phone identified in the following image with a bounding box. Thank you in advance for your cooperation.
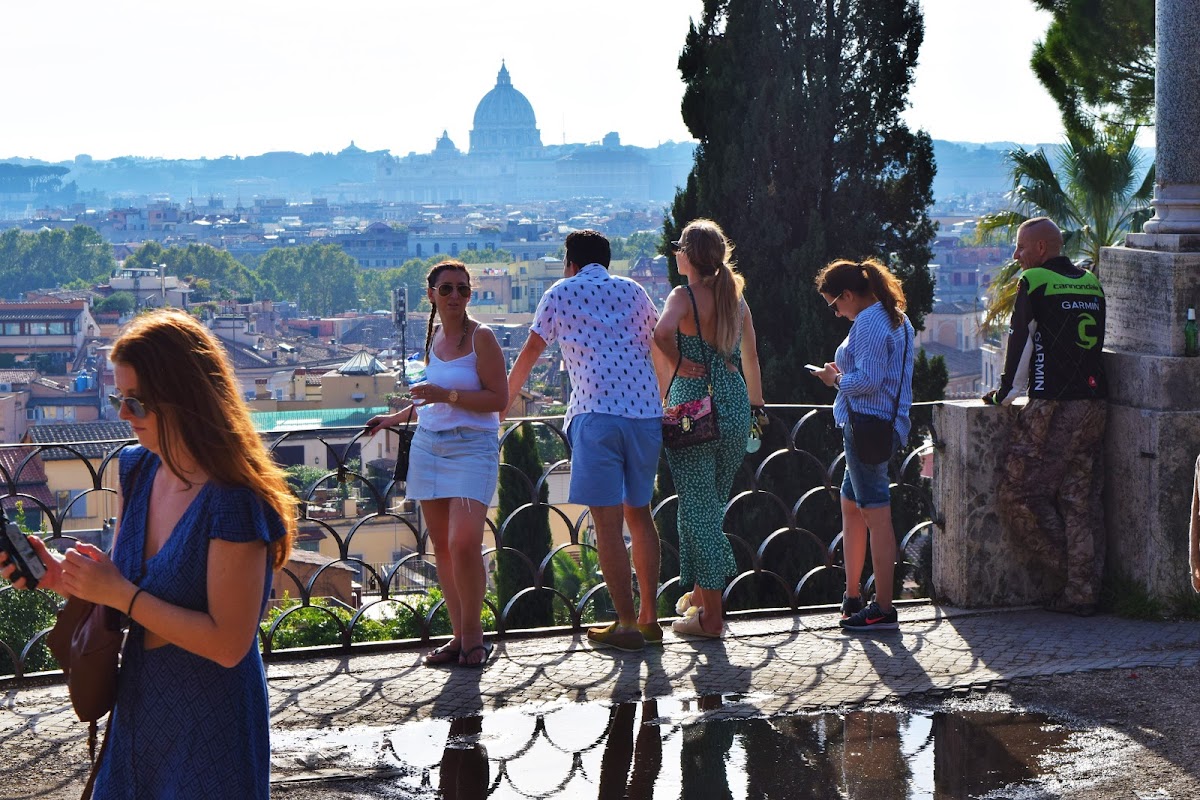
[812,259,913,631]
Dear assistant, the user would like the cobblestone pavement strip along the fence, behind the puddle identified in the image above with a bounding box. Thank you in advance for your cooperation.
[0,606,1200,796]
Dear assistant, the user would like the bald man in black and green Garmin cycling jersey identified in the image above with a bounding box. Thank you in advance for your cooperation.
[983,217,1108,616]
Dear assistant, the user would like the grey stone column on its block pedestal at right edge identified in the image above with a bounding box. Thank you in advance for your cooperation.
[1099,0,1200,597]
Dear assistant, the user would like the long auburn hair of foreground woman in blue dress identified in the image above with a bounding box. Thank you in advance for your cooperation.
[110,309,296,569]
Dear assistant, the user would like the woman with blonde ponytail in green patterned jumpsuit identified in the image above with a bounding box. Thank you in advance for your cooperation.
[654,219,763,637]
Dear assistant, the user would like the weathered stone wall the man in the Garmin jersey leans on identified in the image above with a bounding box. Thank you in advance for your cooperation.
[934,383,1200,608]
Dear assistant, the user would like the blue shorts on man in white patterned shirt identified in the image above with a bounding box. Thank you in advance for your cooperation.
[566,414,662,509]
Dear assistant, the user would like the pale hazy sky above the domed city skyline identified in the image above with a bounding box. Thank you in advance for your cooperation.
[0,0,1113,161]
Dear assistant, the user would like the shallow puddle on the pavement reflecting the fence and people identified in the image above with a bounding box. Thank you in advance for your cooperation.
[274,697,1070,800]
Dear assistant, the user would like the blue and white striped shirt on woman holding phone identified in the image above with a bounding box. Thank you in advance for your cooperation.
[833,302,914,441]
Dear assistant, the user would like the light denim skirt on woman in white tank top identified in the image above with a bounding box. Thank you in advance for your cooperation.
[404,426,500,505]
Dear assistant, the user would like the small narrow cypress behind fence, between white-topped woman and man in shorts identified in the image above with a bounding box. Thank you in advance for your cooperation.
[496,422,554,627]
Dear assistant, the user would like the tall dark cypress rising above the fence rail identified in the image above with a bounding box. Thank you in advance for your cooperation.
[664,0,934,402]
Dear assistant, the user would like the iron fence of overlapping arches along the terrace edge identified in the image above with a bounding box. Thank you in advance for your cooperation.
[0,404,936,679]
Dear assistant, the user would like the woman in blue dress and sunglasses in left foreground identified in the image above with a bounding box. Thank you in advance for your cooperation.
[6,311,295,800]
